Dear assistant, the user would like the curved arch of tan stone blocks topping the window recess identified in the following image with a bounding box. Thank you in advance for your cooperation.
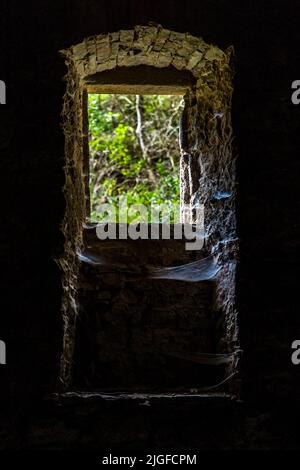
[61,25,231,94]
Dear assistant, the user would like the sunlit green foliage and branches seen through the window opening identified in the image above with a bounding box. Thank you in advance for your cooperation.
[88,94,183,220]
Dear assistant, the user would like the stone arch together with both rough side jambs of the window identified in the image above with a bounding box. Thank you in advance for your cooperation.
[59,25,238,388]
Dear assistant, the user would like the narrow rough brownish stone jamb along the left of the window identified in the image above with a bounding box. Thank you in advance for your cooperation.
[57,64,86,385]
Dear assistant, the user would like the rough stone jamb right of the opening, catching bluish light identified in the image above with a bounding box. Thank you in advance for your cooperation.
[181,57,240,384]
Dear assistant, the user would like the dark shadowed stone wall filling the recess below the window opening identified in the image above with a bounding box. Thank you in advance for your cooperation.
[73,227,225,392]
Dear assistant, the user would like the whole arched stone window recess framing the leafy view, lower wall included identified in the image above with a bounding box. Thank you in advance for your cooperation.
[59,25,240,395]
